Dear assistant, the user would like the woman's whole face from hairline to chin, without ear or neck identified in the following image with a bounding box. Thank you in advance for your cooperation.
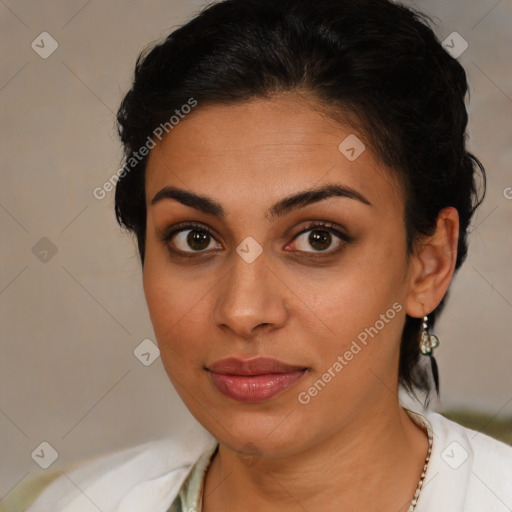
[144,95,416,455]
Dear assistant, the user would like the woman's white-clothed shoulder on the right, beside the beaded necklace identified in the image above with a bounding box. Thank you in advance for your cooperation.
[412,411,512,512]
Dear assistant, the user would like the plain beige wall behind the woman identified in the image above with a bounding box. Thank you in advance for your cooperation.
[0,0,512,499]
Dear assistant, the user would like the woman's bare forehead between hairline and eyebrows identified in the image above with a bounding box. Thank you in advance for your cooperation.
[146,95,400,210]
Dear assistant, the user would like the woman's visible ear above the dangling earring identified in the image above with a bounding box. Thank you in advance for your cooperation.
[405,206,459,318]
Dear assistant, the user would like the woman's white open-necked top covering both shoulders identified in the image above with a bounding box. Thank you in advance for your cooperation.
[27,409,512,512]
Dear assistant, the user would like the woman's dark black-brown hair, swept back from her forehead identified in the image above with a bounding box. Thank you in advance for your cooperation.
[115,0,485,398]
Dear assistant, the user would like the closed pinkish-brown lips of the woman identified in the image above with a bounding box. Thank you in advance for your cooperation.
[208,357,307,403]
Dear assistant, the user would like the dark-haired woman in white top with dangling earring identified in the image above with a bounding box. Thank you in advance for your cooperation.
[23,0,512,512]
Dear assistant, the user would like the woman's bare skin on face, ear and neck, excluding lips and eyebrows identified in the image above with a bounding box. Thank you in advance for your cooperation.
[143,94,458,512]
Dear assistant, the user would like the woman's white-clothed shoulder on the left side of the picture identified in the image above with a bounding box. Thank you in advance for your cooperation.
[19,426,215,512]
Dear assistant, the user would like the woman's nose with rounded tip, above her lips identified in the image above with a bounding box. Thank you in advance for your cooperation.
[213,252,288,340]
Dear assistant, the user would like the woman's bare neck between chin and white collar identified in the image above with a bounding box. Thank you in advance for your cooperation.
[203,402,428,512]
